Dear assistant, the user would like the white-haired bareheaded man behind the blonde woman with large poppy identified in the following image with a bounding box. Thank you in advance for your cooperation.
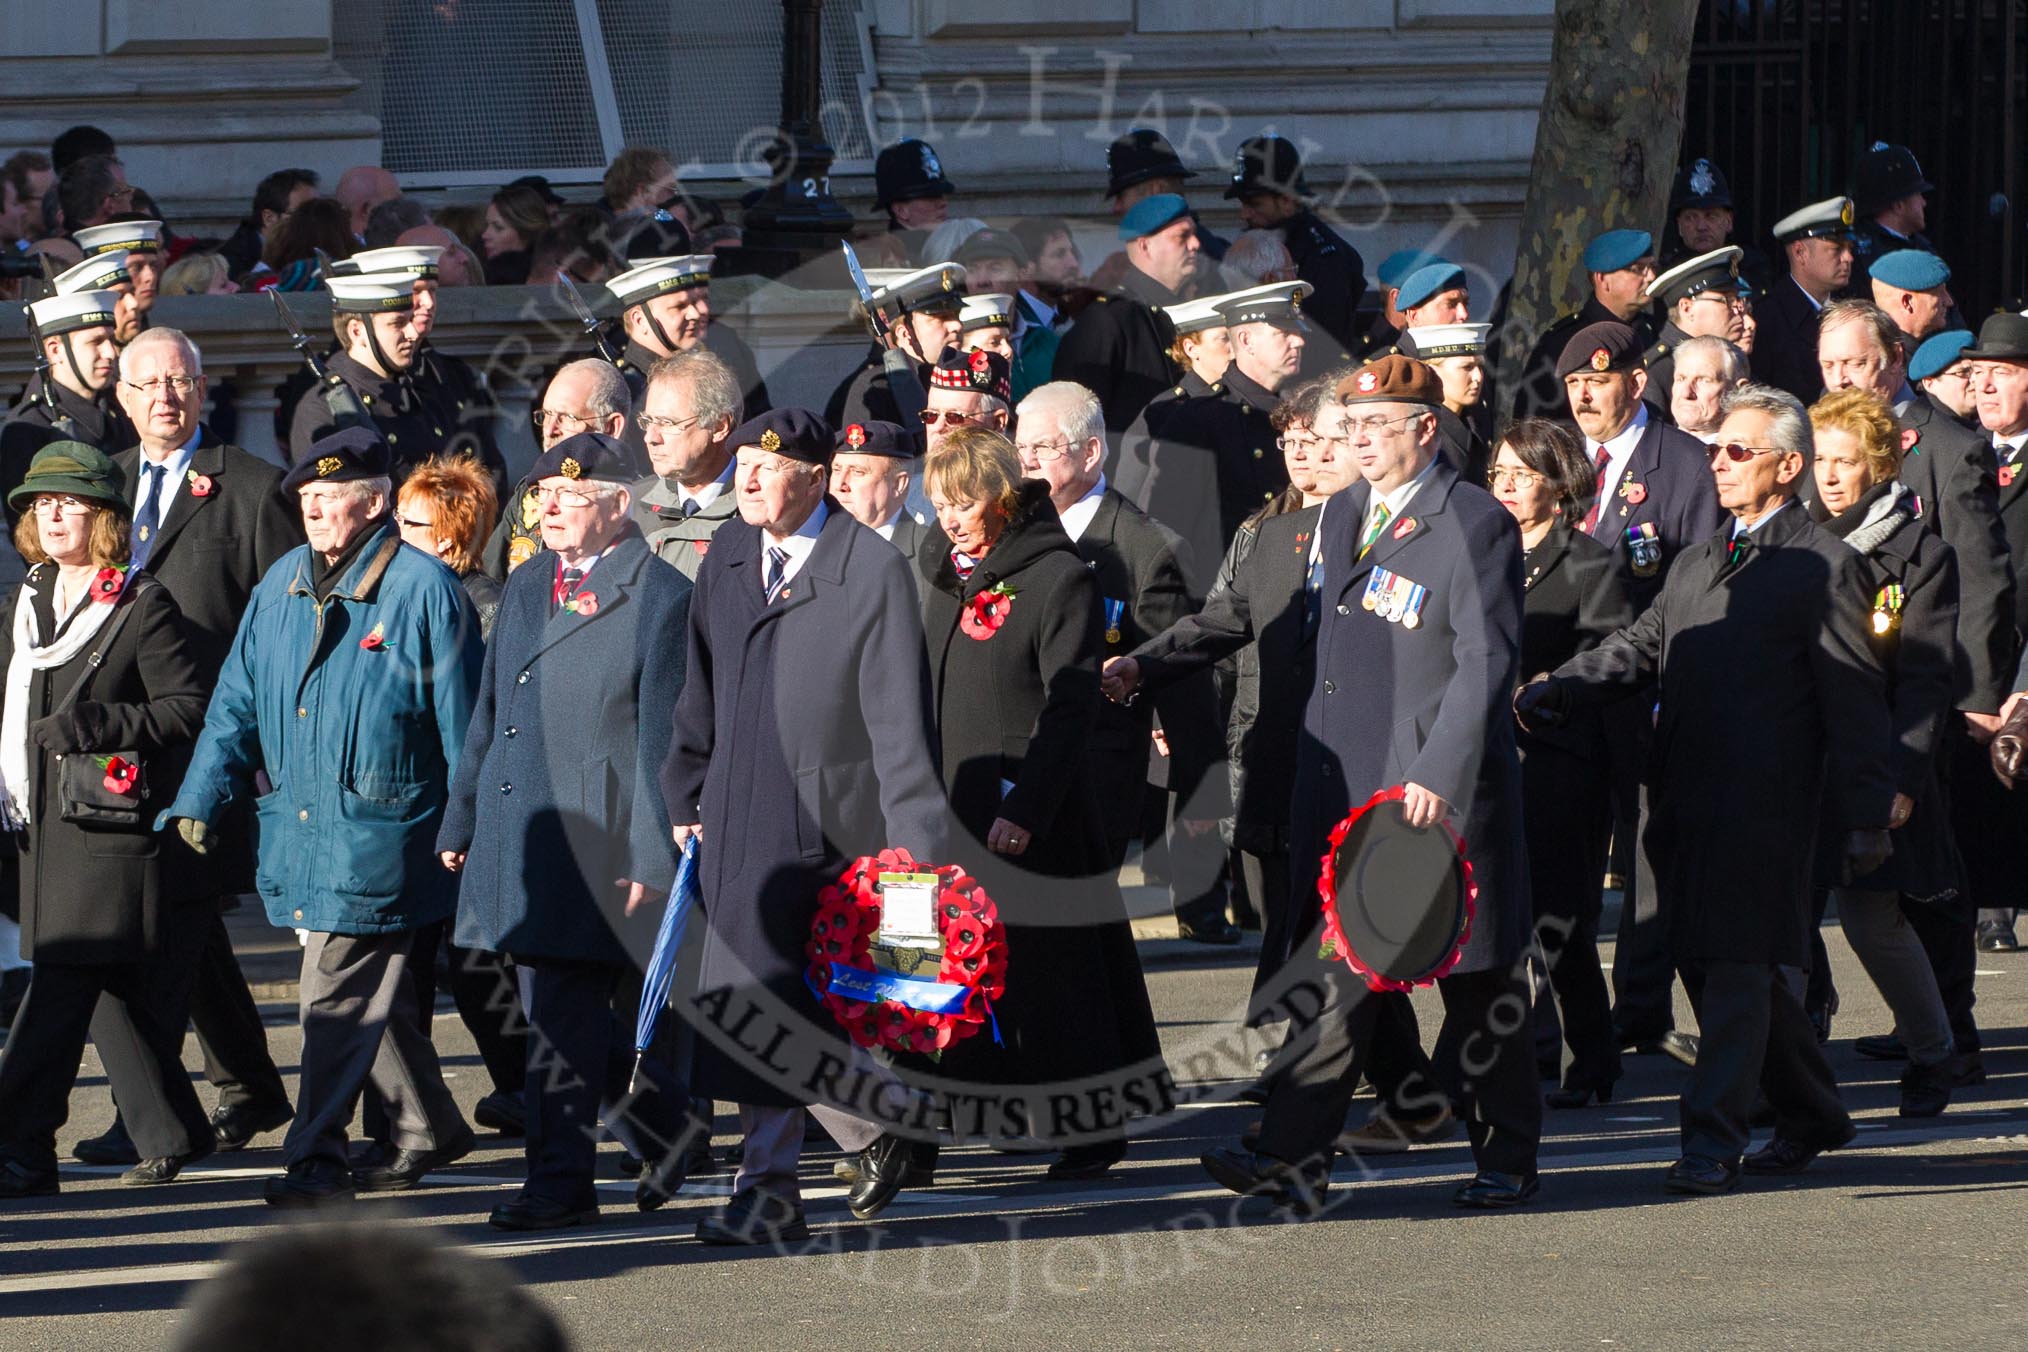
[1014,381,1239,945]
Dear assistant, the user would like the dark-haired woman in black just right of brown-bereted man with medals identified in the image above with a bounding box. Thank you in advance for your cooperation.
[1491,418,1635,1109]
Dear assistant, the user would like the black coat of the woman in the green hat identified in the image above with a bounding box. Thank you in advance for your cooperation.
[0,564,213,963]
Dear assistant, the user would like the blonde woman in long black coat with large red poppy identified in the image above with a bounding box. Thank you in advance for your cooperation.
[917,428,1166,1178]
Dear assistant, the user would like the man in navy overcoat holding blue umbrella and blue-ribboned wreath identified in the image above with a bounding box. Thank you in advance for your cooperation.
[661,409,947,1245]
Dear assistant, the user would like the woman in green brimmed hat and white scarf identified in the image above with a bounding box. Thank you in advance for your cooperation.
[0,442,213,1198]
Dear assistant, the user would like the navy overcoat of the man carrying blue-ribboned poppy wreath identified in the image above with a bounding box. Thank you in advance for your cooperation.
[661,499,949,1105]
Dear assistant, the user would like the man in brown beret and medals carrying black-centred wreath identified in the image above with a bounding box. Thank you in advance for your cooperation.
[1203,357,1541,1214]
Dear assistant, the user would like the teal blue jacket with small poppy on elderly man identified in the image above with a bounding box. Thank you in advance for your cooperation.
[158,523,485,934]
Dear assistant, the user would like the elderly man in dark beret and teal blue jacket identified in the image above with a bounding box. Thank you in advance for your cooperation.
[156,428,484,1206]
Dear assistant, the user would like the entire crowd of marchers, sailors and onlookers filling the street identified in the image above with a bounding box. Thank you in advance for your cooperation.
[0,128,2028,1245]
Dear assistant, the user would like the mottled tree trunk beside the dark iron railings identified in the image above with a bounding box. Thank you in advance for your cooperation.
[1499,0,1697,407]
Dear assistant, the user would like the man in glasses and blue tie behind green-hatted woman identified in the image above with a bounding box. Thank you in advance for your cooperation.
[62,328,302,1163]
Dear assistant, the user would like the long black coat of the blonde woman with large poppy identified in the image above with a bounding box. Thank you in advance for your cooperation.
[917,482,1160,1084]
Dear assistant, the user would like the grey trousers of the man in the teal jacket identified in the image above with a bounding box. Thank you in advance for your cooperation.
[282,930,468,1168]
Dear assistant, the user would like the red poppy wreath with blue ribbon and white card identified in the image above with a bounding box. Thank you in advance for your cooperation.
[803,849,1008,1054]
